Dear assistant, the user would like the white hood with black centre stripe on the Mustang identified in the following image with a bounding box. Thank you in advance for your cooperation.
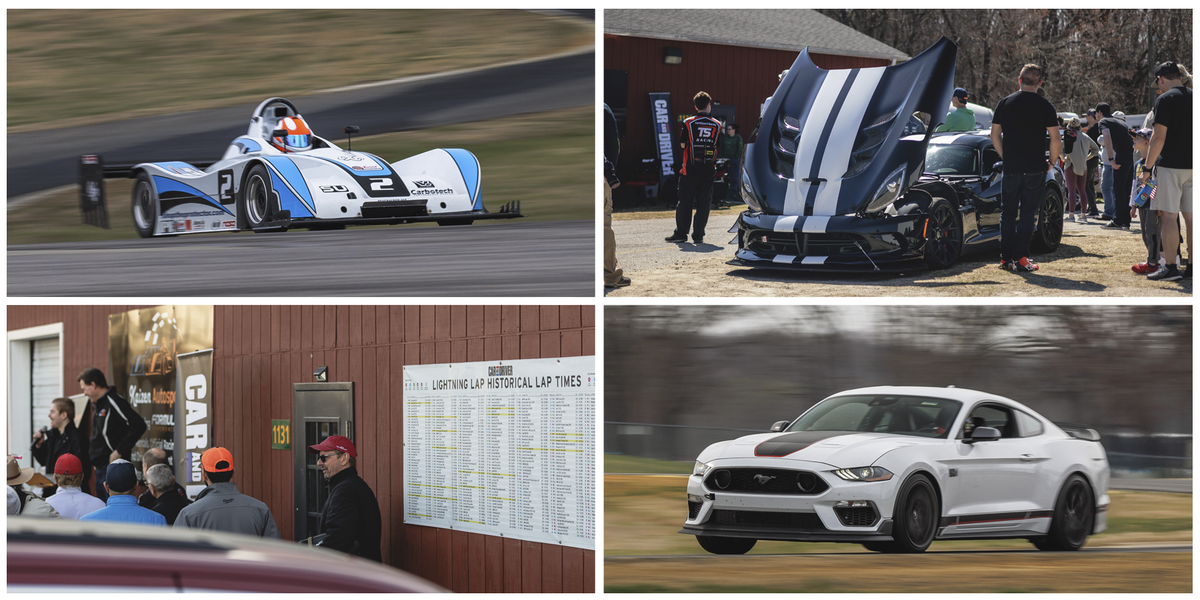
[697,431,932,468]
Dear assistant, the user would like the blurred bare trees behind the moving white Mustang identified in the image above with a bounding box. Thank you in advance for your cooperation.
[604,306,1193,475]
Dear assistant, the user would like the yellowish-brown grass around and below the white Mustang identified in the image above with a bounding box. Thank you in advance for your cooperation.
[604,470,1192,593]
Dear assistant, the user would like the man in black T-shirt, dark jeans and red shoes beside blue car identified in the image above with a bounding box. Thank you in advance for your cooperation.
[991,64,1060,272]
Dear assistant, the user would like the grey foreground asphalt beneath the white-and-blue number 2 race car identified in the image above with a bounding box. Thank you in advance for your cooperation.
[7,221,596,298]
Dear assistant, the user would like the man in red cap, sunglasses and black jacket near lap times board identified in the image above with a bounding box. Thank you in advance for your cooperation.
[308,436,383,563]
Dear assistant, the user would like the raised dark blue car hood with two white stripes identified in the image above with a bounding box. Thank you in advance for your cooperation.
[745,37,958,216]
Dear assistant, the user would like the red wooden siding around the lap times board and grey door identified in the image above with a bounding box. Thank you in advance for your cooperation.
[8,306,595,593]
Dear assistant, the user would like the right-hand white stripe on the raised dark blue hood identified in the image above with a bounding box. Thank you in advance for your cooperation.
[812,67,887,215]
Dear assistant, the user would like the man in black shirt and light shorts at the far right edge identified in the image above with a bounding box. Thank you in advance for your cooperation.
[1142,61,1193,281]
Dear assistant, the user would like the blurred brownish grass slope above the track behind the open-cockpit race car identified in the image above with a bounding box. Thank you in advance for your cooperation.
[7,10,595,133]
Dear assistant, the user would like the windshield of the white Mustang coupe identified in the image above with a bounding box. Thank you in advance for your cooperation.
[787,395,962,438]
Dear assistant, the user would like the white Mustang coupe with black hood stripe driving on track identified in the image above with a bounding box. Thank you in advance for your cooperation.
[679,386,1109,554]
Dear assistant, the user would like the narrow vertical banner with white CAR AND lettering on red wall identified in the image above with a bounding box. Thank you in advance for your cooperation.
[174,348,212,499]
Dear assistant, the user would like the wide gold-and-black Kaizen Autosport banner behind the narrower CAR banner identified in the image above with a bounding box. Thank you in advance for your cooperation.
[108,306,212,492]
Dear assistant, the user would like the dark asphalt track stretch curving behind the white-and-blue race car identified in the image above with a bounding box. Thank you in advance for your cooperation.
[8,49,595,202]
